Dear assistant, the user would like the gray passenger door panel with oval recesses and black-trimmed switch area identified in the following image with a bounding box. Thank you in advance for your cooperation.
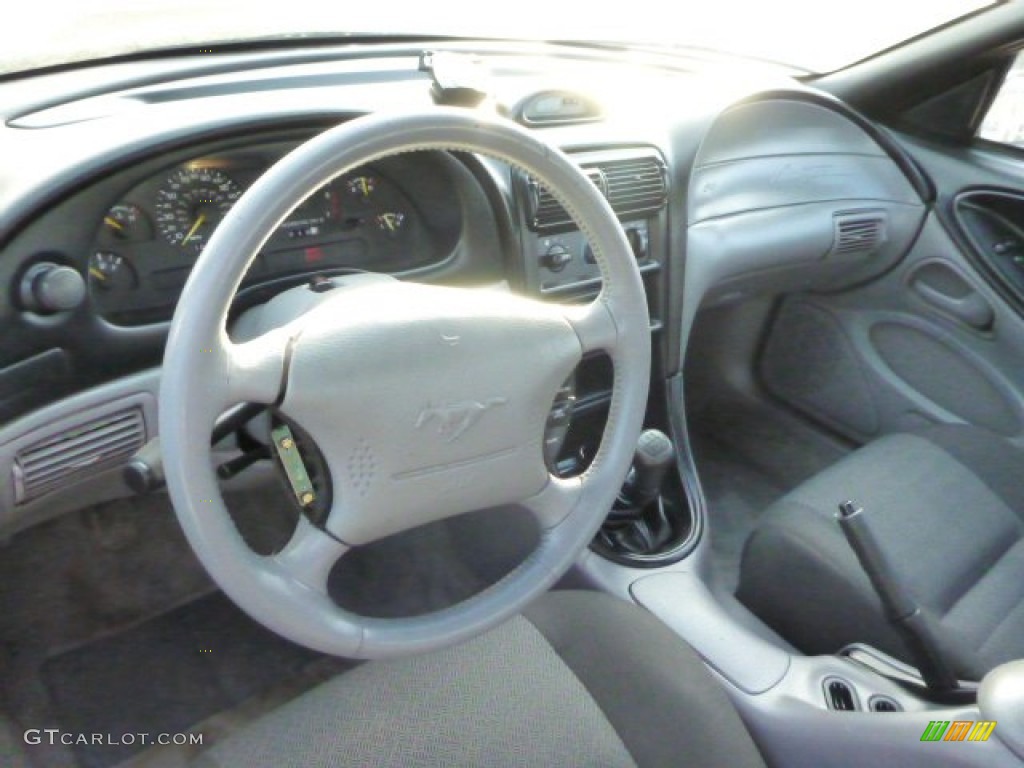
[759,137,1024,444]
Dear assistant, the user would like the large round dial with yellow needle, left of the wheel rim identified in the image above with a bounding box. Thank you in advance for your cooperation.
[155,166,242,253]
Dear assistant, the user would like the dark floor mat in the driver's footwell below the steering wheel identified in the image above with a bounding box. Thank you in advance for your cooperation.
[41,594,350,768]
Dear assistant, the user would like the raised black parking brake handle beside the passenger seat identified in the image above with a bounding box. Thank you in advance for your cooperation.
[838,501,959,692]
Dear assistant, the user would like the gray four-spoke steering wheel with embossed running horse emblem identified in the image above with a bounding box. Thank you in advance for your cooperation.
[159,109,650,658]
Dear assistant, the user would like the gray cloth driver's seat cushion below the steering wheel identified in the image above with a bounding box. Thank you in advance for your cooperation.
[198,592,764,768]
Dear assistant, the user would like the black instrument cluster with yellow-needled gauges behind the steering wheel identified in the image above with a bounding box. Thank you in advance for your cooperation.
[86,144,438,326]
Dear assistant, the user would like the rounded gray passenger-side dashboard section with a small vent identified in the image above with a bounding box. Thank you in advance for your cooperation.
[684,93,927,346]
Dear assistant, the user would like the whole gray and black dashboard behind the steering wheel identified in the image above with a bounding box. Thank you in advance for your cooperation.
[0,43,924,529]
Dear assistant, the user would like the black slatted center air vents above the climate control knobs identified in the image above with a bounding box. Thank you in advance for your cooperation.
[526,155,669,231]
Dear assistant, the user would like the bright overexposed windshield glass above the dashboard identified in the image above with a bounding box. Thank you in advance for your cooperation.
[0,0,994,73]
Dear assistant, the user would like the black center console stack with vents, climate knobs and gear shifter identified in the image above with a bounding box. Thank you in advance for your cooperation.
[514,145,693,567]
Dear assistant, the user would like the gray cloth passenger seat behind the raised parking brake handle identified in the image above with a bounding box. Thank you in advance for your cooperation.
[737,426,1024,680]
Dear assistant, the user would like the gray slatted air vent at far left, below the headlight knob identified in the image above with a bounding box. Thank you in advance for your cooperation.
[14,408,145,504]
